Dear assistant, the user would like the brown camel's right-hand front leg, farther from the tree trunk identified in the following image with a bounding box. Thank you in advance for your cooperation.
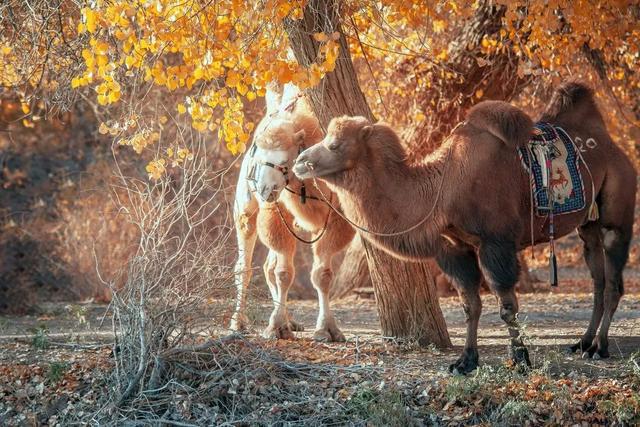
[479,239,531,366]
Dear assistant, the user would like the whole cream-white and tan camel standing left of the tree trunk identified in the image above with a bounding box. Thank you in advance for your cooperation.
[231,86,355,341]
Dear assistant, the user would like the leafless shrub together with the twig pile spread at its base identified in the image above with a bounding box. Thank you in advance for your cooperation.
[61,126,380,425]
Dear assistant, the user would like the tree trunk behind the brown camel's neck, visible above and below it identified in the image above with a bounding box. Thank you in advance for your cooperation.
[288,0,451,347]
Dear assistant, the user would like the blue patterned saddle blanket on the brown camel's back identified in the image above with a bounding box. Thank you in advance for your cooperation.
[518,122,585,216]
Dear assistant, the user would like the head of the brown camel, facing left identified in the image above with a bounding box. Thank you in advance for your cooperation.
[293,116,373,179]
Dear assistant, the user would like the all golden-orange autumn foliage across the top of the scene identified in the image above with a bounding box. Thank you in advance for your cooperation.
[0,0,640,177]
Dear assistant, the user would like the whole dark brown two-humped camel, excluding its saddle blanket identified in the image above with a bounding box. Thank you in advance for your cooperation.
[293,82,636,373]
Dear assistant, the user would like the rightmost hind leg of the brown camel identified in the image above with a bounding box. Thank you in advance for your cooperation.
[582,226,631,359]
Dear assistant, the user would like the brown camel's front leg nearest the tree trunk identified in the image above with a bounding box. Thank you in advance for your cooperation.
[437,248,482,374]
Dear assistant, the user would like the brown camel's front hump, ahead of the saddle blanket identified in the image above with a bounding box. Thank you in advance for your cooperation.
[467,101,533,146]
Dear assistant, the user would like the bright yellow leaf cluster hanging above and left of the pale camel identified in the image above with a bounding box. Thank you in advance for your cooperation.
[71,0,340,157]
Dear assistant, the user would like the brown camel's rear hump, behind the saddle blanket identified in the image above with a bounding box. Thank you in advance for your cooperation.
[540,80,604,123]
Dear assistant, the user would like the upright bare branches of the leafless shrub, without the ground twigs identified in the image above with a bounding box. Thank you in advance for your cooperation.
[63,131,239,423]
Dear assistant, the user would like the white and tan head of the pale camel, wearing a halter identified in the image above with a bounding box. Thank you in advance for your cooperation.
[247,117,305,202]
